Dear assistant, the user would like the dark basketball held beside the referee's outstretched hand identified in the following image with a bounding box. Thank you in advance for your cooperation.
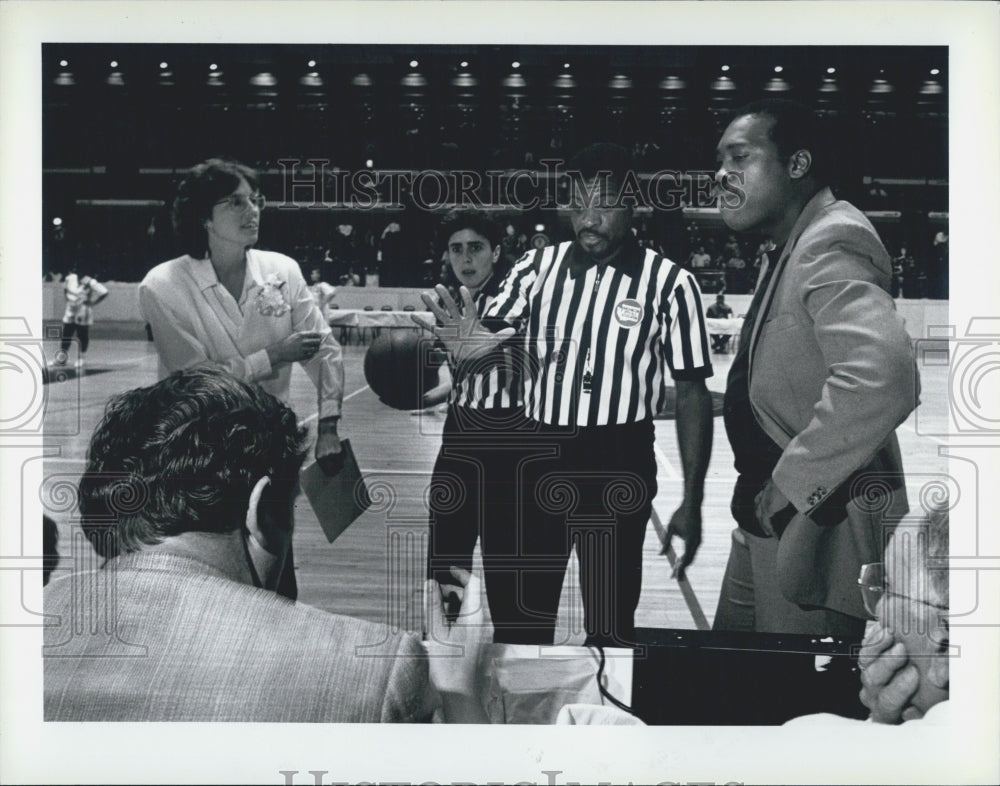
[365,329,438,409]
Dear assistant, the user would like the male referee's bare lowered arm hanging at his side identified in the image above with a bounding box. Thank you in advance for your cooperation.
[664,379,713,578]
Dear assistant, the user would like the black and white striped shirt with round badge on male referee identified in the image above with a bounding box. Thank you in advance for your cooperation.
[483,239,712,426]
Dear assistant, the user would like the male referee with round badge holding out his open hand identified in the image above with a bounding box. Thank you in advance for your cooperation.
[424,144,712,646]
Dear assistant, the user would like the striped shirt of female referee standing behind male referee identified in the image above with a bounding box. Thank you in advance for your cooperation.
[451,277,523,409]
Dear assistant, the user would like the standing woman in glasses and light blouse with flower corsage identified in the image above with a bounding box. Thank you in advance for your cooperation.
[139,159,344,598]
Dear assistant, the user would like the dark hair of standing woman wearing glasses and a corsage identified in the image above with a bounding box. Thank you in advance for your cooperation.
[171,158,260,259]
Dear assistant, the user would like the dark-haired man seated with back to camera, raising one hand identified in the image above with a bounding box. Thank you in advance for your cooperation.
[43,368,485,723]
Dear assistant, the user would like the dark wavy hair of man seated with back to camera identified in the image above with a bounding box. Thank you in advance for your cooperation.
[80,367,307,558]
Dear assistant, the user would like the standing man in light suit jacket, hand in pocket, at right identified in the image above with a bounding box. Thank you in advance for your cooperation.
[714,100,918,639]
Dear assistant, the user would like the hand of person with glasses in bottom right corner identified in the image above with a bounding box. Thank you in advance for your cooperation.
[858,622,923,723]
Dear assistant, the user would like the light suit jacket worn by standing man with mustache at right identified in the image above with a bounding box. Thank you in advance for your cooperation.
[749,189,919,617]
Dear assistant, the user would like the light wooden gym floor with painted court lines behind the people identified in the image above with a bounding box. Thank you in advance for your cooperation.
[42,339,948,643]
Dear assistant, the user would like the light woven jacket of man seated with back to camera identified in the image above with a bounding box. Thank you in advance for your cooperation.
[43,552,440,723]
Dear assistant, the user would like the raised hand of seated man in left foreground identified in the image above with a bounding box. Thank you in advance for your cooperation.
[424,567,489,723]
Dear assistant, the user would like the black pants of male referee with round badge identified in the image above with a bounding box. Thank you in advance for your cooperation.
[484,420,656,646]
